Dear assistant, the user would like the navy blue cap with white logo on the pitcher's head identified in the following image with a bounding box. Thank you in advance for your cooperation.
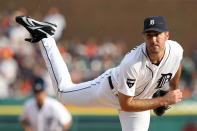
[143,16,167,33]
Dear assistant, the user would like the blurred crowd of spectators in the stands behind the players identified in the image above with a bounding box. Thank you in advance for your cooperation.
[0,7,197,99]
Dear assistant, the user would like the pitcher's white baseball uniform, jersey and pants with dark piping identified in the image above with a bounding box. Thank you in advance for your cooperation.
[40,38,183,131]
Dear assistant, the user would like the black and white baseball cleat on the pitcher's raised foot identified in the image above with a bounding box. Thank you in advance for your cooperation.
[16,16,57,43]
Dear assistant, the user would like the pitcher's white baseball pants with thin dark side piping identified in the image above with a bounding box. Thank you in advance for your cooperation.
[40,37,150,131]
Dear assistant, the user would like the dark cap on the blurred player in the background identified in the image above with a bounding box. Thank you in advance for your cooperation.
[32,78,45,93]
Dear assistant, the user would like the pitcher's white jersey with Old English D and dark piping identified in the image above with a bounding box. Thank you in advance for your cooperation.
[112,40,183,99]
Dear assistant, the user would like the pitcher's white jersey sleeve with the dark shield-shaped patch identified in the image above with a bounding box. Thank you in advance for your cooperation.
[118,52,137,96]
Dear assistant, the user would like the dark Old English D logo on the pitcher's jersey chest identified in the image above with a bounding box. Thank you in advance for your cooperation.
[156,73,172,89]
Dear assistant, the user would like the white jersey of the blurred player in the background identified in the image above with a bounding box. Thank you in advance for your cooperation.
[20,97,72,131]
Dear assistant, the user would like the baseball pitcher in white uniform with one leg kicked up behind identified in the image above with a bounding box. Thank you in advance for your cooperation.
[16,16,183,131]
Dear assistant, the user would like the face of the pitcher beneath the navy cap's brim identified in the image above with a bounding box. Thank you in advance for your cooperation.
[144,31,169,54]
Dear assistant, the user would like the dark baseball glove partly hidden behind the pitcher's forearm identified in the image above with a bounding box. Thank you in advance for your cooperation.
[153,90,170,116]
